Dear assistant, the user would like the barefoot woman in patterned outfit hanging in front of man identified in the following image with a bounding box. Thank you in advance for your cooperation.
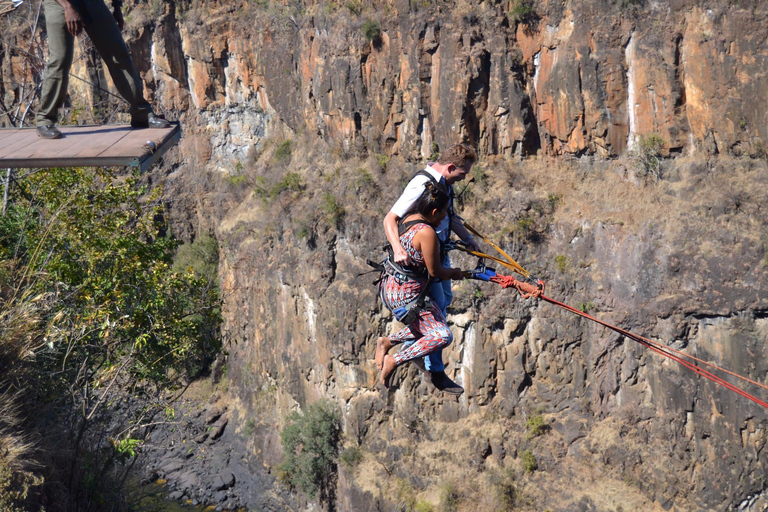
[376,183,464,388]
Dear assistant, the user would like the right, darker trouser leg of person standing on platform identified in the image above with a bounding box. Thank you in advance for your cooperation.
[82,0,152,123]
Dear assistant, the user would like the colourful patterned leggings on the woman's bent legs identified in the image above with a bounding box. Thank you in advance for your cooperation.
[389,303,453,366]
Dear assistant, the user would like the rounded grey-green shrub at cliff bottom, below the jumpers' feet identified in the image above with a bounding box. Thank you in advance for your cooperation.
[279,400,341,502]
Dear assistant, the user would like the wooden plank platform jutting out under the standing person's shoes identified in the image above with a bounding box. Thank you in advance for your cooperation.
[0,124,181,171]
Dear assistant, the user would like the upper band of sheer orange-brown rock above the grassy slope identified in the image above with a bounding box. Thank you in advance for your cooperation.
[129,2,768,162]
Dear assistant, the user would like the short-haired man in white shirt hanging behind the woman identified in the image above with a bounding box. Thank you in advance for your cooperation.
[383,144,480,395]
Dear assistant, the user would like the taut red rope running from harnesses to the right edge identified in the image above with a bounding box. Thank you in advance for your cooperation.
[491,275,768,409]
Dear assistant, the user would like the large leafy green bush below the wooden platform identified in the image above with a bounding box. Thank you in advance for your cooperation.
[0,169,220,511]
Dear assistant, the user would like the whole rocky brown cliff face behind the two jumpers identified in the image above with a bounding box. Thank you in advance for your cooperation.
[0,0,768,511]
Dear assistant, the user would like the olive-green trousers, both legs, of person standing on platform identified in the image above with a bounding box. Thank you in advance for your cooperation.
[35,0,152,126]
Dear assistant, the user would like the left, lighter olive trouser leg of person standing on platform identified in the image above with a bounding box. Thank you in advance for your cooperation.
[35,0,75,126]
